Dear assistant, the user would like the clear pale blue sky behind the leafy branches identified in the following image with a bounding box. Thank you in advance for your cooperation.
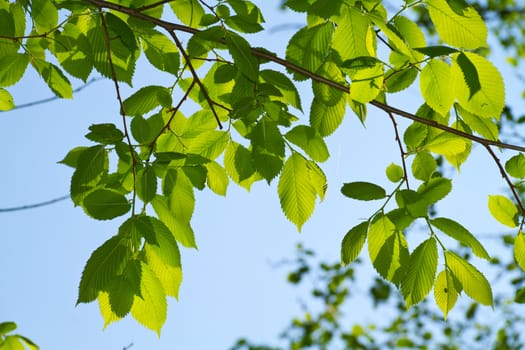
[0,1,523,350]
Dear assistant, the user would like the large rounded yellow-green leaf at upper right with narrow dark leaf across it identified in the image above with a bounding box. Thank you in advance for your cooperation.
[452,52,505,120]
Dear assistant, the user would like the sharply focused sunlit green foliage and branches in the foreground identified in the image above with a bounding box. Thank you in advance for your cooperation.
[0,0,525,344]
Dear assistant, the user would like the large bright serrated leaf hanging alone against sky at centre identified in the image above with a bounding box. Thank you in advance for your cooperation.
[277,153,316,231]
